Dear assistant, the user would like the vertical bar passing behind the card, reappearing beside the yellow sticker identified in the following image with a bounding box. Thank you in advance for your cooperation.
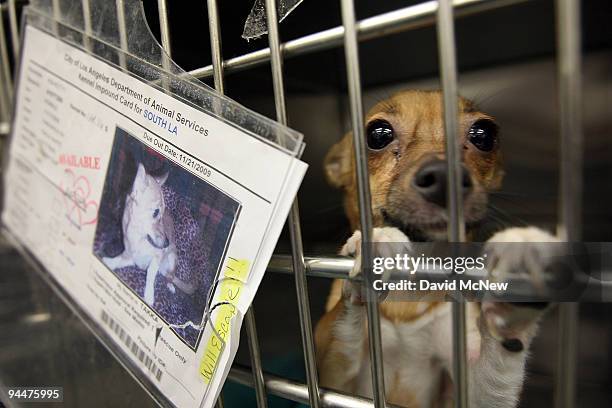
[207,0,268,408]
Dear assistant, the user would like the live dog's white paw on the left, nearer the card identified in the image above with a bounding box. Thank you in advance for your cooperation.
[340,227,410,304]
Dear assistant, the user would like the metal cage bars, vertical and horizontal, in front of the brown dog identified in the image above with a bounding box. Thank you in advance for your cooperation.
[0,0,582,408]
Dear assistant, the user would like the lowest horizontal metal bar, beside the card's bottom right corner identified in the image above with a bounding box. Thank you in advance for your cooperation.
[228,364,404,408]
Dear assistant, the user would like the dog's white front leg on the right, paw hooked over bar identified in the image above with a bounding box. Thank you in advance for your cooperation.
[468,227,557,408]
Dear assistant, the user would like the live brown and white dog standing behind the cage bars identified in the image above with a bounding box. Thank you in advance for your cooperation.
[315,91,556,408]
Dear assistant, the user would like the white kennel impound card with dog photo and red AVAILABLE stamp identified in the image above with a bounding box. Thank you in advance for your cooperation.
[2,26,306,407]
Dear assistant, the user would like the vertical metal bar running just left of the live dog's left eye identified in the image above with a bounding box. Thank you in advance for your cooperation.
[340,0,386,407]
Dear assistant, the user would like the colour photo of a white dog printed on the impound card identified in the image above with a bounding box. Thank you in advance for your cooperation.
[92,127,241,350]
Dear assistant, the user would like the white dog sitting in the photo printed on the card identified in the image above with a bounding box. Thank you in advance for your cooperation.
[102,163,195,306]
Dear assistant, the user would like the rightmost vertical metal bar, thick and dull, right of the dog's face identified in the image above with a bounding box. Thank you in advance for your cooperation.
[555,0,583,408]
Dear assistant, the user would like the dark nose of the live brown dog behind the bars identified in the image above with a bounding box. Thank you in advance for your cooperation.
[412,160,472,208]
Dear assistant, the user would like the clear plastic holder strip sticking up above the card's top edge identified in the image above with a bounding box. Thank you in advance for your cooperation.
[25,0,304,157]
